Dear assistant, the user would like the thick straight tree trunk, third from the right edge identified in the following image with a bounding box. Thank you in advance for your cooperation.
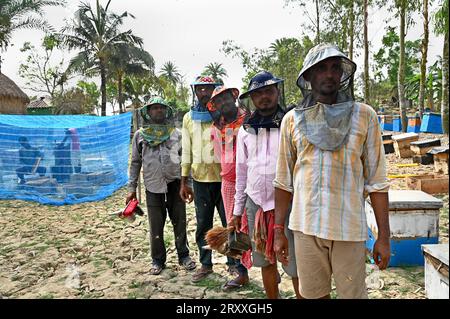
[397,0,408,132]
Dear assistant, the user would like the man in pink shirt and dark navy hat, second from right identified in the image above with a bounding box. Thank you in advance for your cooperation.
[233,71,298,299]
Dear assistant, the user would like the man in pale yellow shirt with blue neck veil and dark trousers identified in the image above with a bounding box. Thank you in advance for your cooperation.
[180,76,235,282]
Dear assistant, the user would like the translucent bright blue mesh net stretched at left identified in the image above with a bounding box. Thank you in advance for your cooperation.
[0,113,131,205]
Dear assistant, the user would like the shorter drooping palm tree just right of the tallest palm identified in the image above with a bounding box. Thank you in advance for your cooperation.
[109,43,155,113]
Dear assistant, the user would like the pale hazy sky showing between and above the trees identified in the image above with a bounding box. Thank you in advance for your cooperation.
[2,0,443,114]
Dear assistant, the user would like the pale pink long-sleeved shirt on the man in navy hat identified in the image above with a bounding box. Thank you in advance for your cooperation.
[233,127,280,216]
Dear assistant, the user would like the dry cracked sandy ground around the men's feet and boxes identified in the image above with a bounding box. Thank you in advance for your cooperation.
[0,134,448,299]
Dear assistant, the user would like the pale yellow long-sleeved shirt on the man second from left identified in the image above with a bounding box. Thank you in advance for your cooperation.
[181,112,222,183]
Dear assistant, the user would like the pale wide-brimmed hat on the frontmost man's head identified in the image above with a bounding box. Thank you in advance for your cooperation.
[297,43,356,93]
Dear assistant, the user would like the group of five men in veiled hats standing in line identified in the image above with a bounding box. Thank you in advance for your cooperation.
[126,44,390,298]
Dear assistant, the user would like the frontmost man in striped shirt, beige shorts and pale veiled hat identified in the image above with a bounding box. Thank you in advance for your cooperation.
[274,44,390,298]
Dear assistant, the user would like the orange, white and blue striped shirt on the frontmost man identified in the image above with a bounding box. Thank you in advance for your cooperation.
[273,103,389,241]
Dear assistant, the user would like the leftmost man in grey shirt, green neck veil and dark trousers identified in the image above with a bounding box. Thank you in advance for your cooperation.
[126,97,196,275]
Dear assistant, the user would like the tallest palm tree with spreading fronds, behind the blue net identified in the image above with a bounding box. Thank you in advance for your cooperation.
[58,0,143,116]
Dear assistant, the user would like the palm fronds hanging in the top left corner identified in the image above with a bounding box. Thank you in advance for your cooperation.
[0,0,66,71]
